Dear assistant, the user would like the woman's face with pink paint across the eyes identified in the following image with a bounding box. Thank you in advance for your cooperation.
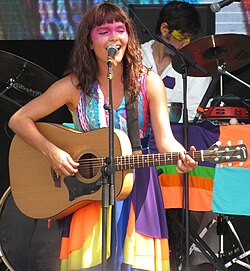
[91,22,128,63]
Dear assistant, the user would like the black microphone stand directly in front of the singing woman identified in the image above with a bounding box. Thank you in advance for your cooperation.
[101,58,115,271]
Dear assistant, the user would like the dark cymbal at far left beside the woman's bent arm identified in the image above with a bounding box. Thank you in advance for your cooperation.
[0,50,58,112]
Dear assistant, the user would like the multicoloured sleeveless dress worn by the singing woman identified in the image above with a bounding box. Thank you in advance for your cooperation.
[60,74,170,271]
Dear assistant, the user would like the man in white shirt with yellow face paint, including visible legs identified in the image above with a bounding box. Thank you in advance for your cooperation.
[142,1,217,271]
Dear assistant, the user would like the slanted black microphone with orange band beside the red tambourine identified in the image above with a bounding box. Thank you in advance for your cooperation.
[193,70,221,123]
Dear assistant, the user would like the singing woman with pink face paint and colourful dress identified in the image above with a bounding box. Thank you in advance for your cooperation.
[9,2,197,271]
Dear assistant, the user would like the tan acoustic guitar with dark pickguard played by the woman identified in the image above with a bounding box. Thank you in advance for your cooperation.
[9,123,247,219]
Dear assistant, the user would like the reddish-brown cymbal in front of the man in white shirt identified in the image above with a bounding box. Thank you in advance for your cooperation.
[172,34,250,77]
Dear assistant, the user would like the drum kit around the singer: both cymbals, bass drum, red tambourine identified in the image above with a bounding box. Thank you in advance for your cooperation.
[0,34,250,271]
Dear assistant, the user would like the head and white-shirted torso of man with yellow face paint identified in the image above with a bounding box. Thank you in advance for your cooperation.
[142,1,212,121]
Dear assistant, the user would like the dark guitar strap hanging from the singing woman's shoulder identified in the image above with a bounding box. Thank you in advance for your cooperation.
[125,91,142,151]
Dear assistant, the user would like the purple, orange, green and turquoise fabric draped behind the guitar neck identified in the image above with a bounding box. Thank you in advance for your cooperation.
[154,120,250,215]
